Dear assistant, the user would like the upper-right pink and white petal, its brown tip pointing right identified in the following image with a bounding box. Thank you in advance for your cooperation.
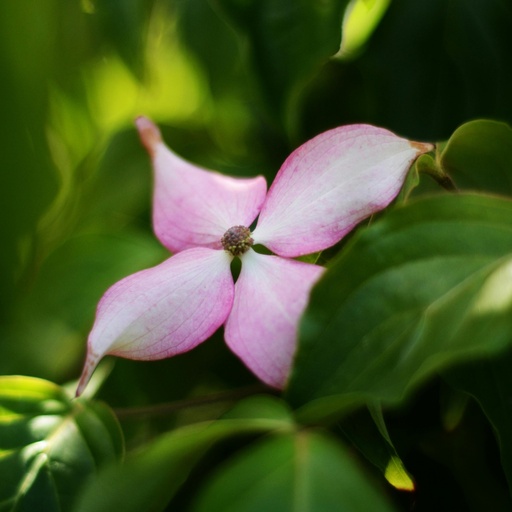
[253,125,433,257]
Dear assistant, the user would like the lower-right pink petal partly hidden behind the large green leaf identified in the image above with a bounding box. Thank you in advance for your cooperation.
[225,250,324,388]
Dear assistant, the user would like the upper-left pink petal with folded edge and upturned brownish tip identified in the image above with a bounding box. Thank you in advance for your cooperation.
[136,117,267,252]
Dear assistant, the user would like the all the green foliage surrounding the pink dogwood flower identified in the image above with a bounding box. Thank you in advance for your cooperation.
[0,0,512,512]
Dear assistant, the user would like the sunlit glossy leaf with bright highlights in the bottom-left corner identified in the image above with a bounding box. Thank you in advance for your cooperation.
[0,376,123,512]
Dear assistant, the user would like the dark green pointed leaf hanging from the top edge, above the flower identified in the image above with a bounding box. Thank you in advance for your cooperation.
[214,0,348,128]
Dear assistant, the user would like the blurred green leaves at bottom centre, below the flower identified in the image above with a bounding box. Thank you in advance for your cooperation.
[75,397,400,512]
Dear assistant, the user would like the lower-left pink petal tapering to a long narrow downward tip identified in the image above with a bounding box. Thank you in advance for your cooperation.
[77,247,234,394]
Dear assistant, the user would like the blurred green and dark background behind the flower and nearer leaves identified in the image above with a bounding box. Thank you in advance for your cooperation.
[0,0,512,405]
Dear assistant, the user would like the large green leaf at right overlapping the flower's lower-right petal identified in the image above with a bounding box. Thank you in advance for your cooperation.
[288,194,512,414]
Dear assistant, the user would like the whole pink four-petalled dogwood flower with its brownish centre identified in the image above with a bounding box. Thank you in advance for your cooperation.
[77,117,432,395]
